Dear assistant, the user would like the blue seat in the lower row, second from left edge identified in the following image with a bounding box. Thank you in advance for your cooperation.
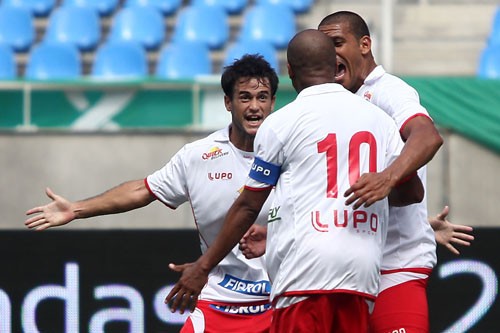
[25,43,82,80]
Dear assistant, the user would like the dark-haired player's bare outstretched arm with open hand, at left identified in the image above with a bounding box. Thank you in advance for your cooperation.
[24,179,155,231]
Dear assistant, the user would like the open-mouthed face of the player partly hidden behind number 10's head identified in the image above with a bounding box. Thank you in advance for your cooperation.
[318,23,365,93]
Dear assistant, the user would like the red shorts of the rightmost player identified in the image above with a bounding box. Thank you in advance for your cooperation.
[370,278,429,333]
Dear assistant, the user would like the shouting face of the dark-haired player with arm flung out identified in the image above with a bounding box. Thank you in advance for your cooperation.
[224,78,275,136]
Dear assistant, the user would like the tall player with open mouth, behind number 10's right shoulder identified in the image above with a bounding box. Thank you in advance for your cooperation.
[318,11,473,333]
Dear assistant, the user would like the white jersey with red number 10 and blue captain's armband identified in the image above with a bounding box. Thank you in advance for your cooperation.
[246,83,403,306]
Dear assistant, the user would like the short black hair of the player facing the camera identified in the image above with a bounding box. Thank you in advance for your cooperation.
[221,54,279,98]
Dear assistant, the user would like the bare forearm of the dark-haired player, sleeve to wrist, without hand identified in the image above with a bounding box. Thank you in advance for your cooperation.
[72,180,154,219]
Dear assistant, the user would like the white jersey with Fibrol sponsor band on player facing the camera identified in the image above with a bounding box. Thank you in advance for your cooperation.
[146,128,271,303]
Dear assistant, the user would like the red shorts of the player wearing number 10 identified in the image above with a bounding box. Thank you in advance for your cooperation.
[271,293,369,333]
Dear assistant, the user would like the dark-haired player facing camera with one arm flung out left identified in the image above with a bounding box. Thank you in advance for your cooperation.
[25,55,278,333]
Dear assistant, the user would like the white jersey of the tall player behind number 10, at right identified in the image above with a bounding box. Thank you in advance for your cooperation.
[356,66,437,271]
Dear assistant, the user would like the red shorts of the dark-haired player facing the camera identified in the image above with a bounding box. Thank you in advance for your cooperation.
[180,301,273,333]
